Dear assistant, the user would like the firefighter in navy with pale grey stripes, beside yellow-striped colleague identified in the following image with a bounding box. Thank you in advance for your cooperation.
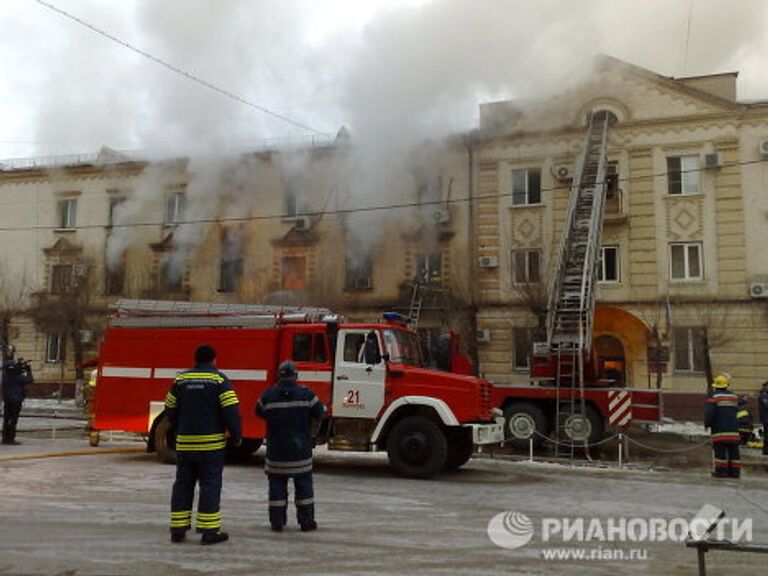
[256,360,325,532]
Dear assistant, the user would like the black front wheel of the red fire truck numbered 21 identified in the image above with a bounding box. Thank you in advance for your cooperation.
[387,416,448,478]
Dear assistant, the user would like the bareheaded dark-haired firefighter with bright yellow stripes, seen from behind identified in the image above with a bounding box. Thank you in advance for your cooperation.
[165,345,242,544]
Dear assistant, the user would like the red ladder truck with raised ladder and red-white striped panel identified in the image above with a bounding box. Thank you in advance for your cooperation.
[493,111,662,446]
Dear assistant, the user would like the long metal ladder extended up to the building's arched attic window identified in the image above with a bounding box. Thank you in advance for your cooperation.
[547,112,609,355]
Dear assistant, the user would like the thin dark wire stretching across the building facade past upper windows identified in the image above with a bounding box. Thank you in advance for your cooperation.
[0,158,768,232]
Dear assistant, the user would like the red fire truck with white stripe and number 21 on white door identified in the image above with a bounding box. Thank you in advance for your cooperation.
[93,300,504,478]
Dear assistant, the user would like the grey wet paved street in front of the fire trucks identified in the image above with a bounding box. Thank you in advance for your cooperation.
[0,439,768,576]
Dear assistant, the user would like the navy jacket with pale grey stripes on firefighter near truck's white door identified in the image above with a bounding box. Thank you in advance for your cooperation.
[256,378,325,475]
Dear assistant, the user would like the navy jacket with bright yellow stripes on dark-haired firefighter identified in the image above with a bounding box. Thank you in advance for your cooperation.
[165,364,242,452]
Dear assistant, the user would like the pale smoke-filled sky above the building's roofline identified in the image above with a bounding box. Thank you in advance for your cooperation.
[0,0,768,158]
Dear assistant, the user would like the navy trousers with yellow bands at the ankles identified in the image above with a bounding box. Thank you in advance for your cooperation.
[171,450,224,532]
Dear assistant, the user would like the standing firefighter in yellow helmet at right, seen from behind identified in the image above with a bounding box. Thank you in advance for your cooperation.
[704,374,741,478]
